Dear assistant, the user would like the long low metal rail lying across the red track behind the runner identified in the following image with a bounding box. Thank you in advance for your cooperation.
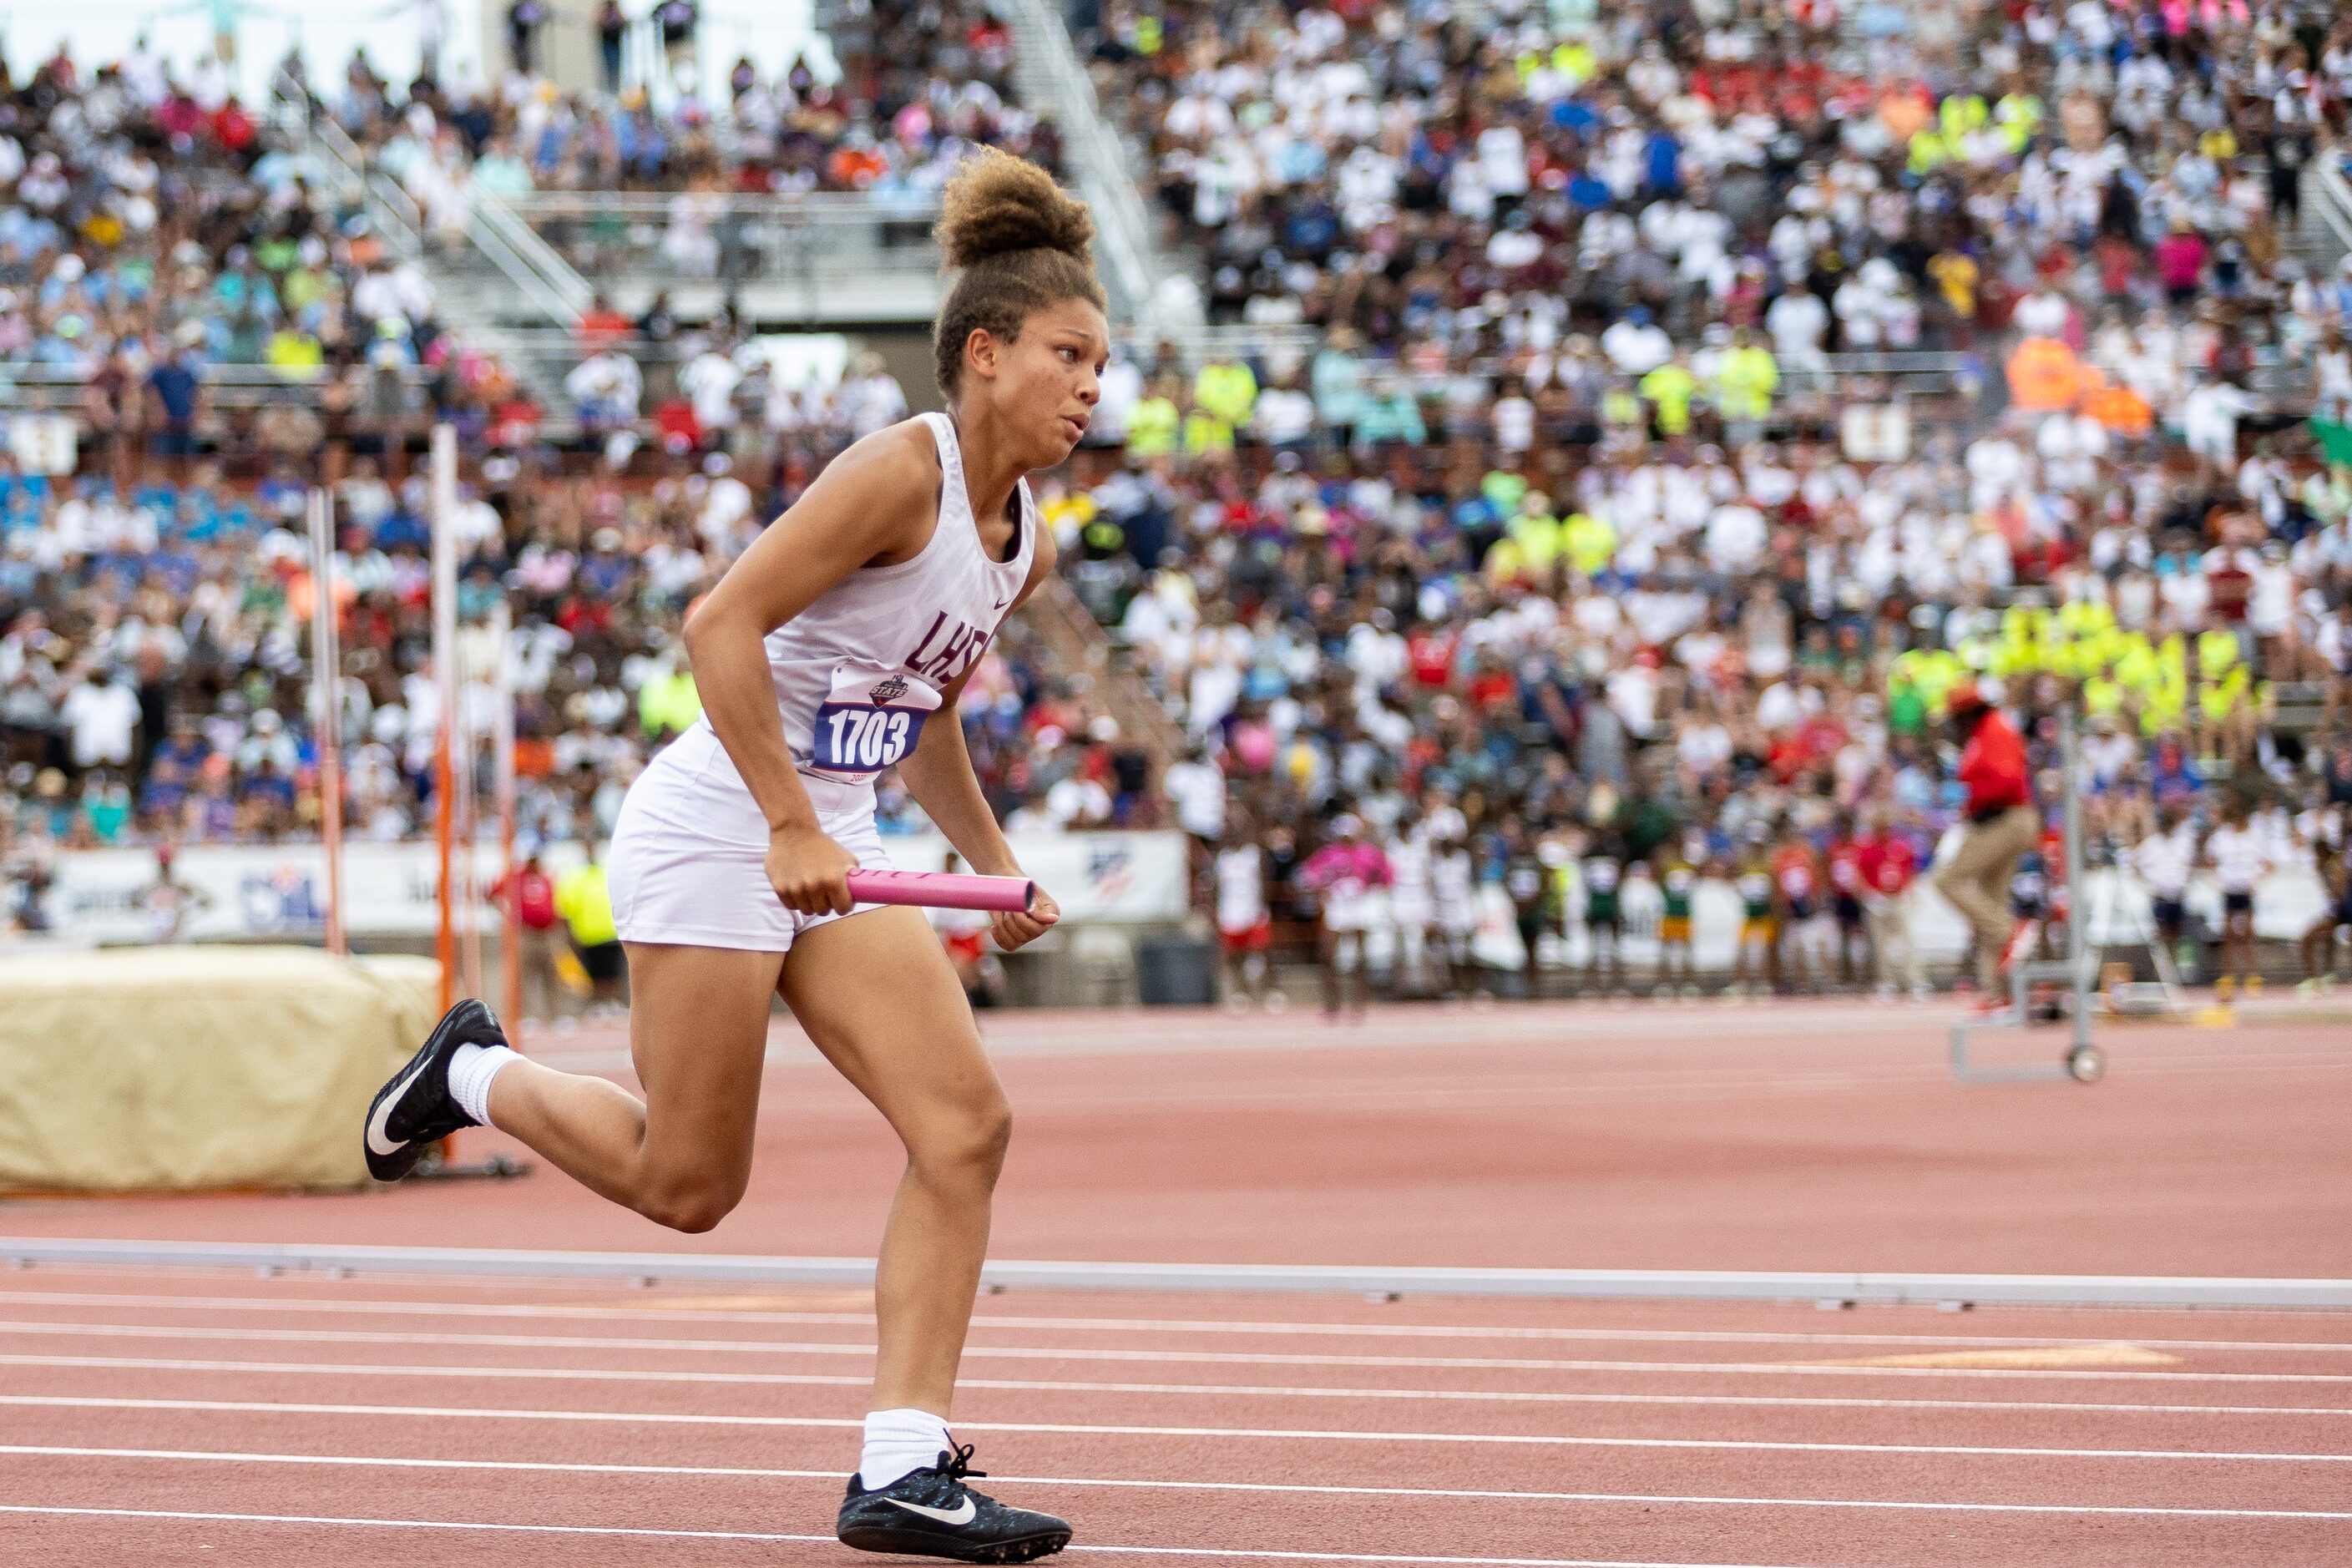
[13,1237,2352,1309]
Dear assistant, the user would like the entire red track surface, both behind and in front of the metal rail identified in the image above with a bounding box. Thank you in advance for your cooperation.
[0,1004,2352,1568]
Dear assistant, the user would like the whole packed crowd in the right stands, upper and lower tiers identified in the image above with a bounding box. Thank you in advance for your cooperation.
[1056,0,2352,983]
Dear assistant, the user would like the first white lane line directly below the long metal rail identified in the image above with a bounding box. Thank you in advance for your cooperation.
[0,1291,2352,1354]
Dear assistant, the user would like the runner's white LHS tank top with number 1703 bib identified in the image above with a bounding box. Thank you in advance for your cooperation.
[699,414,1037,790]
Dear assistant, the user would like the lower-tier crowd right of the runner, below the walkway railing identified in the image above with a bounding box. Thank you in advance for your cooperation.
[1077,416,2352,1001]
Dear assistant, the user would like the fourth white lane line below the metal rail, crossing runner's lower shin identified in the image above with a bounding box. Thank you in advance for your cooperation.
[0,1394,2352,1464]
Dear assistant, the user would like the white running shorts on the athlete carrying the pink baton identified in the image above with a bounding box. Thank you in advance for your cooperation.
[607,724,892,952]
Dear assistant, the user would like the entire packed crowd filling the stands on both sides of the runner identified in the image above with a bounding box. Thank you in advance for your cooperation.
[0,0,2352,989]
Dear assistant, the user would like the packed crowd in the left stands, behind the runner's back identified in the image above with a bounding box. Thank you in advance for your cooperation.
[0,30,1124,924]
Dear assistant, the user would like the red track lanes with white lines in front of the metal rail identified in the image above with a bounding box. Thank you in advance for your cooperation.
[0,1267,2352,1568]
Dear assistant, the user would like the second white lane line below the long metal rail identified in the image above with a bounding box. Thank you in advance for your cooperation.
[0,1319,2352,1387]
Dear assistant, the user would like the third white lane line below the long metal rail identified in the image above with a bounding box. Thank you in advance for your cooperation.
[13,1354,2352,1418]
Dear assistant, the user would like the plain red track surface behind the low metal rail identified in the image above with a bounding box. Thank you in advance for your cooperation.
[0,1001,2352,1277]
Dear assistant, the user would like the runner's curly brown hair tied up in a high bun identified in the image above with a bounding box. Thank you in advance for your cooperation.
[932,148,1108,397]
